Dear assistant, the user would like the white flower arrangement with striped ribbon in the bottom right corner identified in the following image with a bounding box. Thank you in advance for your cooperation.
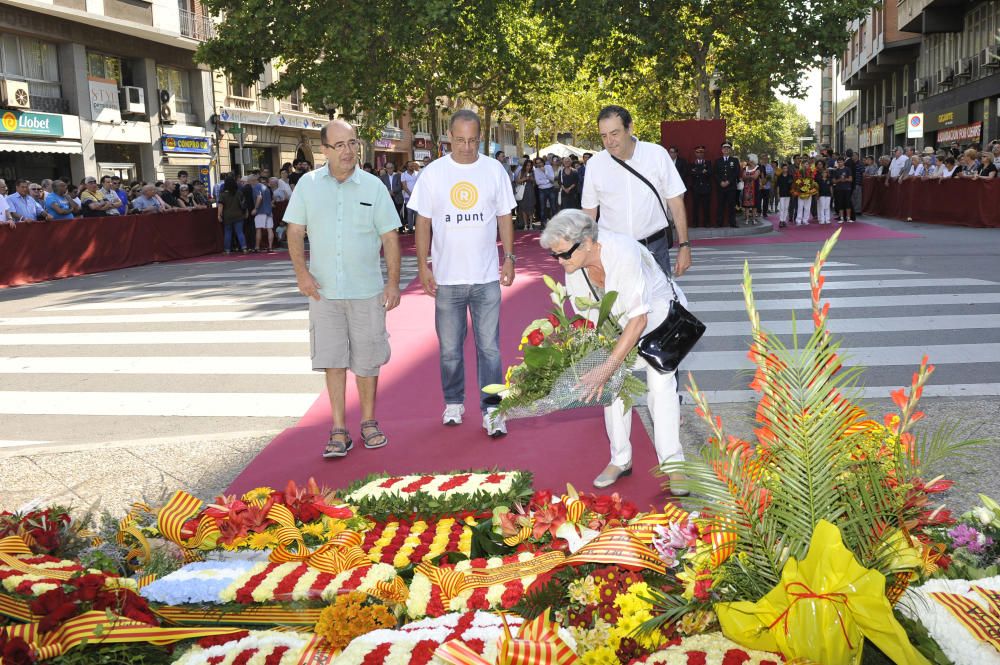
[897,576,1000,665]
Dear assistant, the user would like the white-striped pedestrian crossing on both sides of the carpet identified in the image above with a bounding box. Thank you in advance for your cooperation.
[0,245,1000,449]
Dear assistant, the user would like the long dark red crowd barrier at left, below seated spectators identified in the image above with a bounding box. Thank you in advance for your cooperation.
[0,209,222,286]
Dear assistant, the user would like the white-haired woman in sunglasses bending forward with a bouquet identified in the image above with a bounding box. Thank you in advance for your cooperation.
[541,210,687,496]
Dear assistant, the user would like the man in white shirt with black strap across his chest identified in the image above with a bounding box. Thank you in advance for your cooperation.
[581,106,691,277]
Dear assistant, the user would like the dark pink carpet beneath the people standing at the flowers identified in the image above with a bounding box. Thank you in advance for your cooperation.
[227,233,667,508]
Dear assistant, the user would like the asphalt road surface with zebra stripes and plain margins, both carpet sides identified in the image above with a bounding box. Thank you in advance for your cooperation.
[0,215,1000,507]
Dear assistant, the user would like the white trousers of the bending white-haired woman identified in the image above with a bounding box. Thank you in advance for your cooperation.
[604,358,684,467]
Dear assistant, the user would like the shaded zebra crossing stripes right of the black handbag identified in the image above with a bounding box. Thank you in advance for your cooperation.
[679,248,1000,403]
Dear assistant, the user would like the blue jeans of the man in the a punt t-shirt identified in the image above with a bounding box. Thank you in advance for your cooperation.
[434,282,503,413]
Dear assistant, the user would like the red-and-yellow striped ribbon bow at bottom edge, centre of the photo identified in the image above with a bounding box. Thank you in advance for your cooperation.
[434,610,579,665]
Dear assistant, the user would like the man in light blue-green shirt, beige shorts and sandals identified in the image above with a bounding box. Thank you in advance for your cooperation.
[284,120,400,458]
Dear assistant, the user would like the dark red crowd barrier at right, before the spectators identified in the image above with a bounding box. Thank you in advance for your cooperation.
[861,177,1000,227]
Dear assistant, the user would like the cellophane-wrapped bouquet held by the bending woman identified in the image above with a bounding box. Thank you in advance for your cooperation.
[484,275,646,419]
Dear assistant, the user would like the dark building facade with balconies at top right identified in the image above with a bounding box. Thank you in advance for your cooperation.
[837,0,1000,156]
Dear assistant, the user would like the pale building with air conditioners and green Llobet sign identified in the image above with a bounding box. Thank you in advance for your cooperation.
[0,0,213,182]
